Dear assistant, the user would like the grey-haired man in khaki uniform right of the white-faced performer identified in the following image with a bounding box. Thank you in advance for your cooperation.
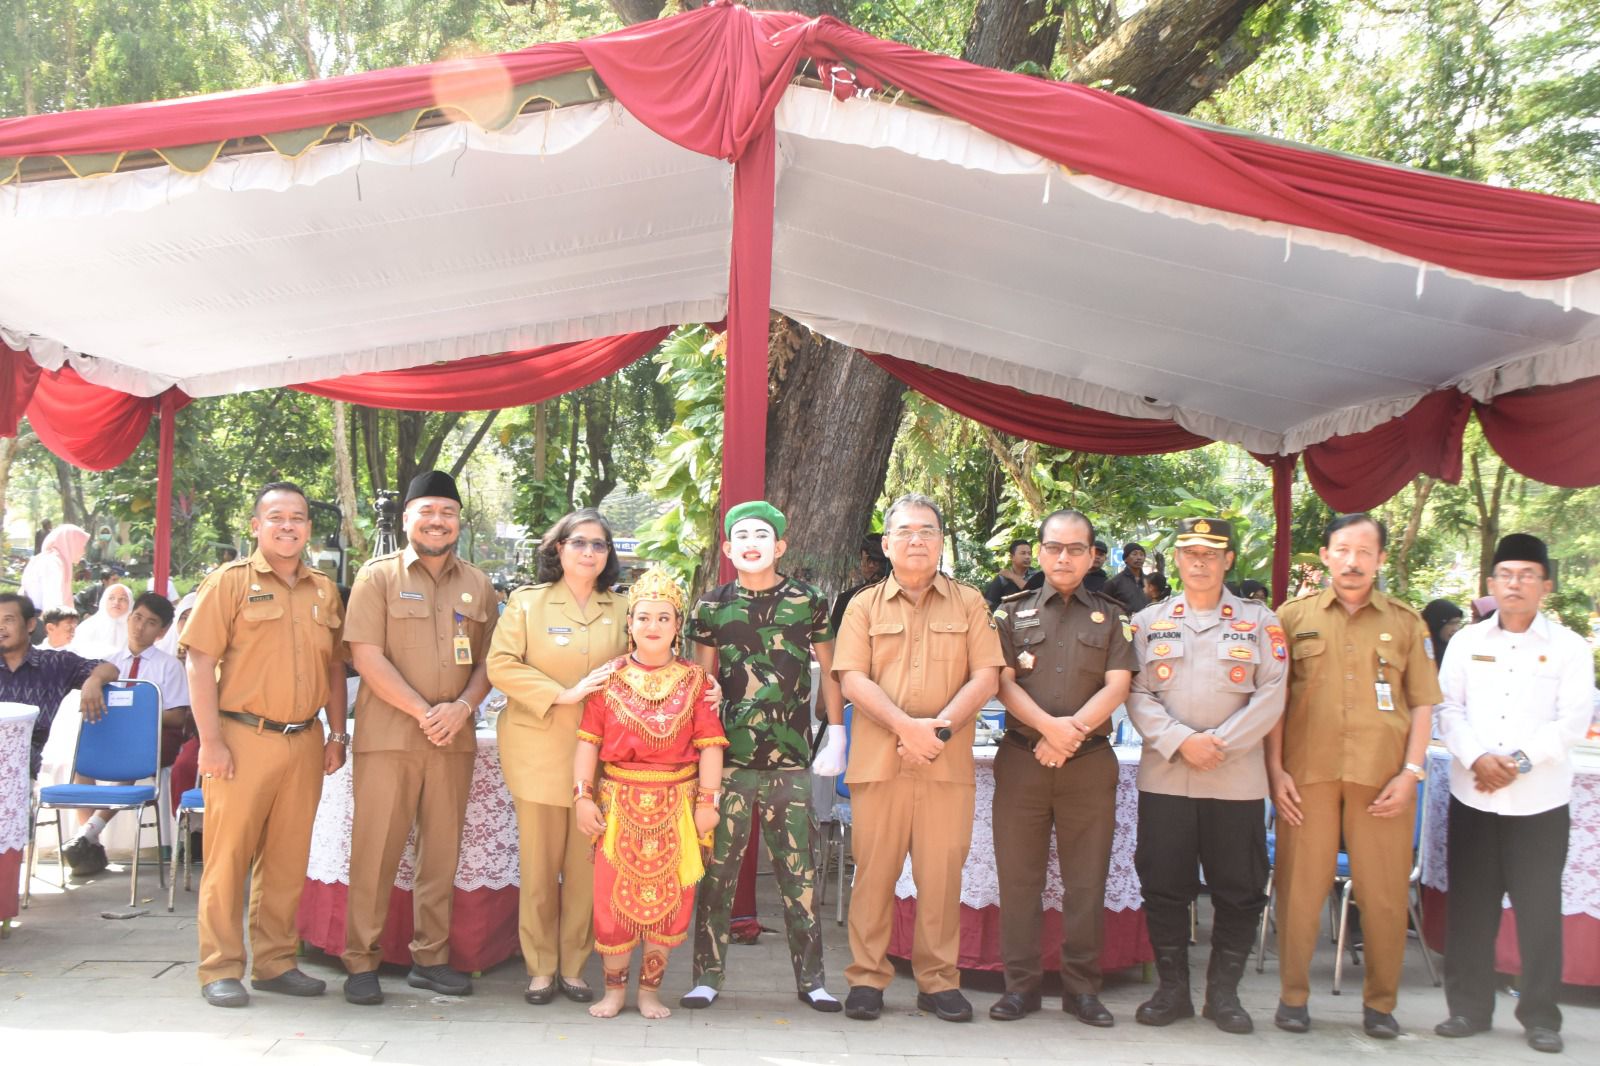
[834,495,1005,1021]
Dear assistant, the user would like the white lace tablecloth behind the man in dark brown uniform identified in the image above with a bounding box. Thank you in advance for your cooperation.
[894,747,1141,911]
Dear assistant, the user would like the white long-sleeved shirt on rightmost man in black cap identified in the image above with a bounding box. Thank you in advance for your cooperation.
[1438,615,1594,815]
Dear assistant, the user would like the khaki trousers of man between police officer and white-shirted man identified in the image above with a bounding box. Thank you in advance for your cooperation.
[1272,781,1416,1013]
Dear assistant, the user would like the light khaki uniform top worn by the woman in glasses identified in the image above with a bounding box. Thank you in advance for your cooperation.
[490,581,627,807]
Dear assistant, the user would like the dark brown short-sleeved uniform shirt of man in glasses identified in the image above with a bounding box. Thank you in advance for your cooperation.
[995,583,1139,744]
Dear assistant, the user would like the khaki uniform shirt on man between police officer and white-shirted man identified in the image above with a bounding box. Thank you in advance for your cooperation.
[1282,589,1442,787]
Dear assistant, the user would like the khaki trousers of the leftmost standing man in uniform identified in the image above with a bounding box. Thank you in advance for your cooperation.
[197,719,323,984]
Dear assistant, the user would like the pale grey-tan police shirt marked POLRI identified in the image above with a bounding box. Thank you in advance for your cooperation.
[1128,589,1288,799]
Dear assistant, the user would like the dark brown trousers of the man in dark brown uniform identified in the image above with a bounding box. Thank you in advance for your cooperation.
[994,743,1120,996]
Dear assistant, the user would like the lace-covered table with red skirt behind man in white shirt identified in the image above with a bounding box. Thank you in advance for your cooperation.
[1422,747,1600,986]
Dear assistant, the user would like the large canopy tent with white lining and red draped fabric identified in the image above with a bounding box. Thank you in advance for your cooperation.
[0,2,1600,592]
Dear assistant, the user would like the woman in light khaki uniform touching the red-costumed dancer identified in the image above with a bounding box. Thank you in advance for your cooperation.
[488,509,627,1005]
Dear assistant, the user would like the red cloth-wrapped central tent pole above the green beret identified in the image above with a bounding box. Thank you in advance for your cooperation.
[714,118,778,581]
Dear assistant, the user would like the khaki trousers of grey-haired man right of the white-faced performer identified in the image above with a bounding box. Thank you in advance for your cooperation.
[845,767,976,992]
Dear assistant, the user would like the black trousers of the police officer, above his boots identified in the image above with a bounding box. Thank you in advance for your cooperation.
[1133,792,1267,954]
